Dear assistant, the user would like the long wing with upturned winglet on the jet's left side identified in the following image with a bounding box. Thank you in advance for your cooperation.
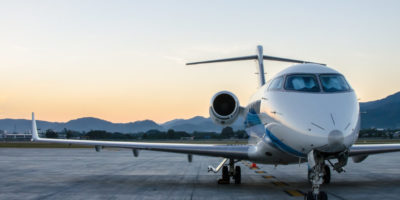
[32,113,250,159]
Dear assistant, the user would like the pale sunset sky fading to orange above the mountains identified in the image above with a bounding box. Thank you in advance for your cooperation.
[0,0,400,123]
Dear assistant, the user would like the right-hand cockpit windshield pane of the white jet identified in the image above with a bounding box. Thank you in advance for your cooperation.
[319,74,350,92]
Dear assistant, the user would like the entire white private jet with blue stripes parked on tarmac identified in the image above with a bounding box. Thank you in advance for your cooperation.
[32,46,400,200]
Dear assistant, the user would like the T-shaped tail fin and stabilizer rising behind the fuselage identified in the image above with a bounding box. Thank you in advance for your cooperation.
[186,45,325,87]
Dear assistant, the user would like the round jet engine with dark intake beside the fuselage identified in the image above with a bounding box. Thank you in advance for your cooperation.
[210,91,240,126]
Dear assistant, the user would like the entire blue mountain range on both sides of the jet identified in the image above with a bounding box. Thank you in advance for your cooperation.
[0,92,400,133]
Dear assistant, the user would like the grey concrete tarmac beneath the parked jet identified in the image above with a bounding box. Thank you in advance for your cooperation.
[0,148,400,200]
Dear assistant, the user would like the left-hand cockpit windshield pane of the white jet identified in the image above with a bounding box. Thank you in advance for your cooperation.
[285,74,320,92]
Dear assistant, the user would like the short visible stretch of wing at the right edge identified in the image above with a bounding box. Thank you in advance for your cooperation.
[349,144,400,156]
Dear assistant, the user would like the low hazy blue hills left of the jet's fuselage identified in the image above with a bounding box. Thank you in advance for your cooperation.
[0,116,243,133]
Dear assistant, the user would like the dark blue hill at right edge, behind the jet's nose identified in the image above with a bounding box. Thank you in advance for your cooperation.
[360,92,400,129]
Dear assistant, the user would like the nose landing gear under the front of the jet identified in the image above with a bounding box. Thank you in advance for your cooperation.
[304,150,330,200]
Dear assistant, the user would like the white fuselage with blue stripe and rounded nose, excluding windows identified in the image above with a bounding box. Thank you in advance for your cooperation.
[245,64,360,164]
